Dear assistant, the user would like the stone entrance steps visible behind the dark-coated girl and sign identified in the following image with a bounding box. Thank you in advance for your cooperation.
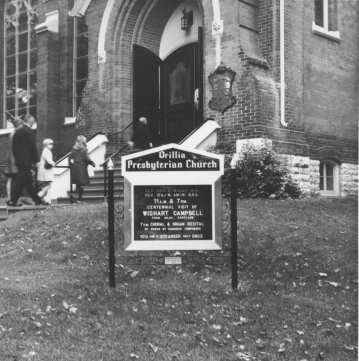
[57,167,123,204]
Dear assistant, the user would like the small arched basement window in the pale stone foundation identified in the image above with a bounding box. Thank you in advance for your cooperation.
[319,160,339,196]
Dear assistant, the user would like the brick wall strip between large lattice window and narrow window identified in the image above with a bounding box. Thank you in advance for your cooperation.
[37,0,73,157]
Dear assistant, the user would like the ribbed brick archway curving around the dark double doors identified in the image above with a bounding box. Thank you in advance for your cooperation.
[106,0,208,134]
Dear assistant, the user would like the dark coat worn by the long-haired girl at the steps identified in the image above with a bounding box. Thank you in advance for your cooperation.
[69,149,95,186]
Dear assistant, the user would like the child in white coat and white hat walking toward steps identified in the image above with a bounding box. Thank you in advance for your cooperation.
[37,139,55,203]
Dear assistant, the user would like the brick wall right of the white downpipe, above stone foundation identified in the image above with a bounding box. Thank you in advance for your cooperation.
[285,0,359,162]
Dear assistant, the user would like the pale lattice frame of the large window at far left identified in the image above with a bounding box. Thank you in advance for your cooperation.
[0,0,37,129]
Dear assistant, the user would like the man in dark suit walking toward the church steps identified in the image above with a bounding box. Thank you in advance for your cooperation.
[8,114,42,206]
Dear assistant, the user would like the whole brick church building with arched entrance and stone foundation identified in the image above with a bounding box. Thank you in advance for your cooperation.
[0,0,359,196]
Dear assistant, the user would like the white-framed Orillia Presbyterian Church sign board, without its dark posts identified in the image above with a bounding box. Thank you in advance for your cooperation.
[122,144,224,251]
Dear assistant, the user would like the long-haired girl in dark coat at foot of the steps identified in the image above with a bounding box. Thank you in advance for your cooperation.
[69,135,95,202]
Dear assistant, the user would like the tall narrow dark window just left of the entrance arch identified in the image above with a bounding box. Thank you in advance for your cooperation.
[72,16,88,117]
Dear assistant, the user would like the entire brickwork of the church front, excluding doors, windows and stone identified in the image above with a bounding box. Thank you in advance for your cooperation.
[0,0,359,195]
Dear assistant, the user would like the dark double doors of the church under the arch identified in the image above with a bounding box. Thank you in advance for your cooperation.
[133,37,202,144]
